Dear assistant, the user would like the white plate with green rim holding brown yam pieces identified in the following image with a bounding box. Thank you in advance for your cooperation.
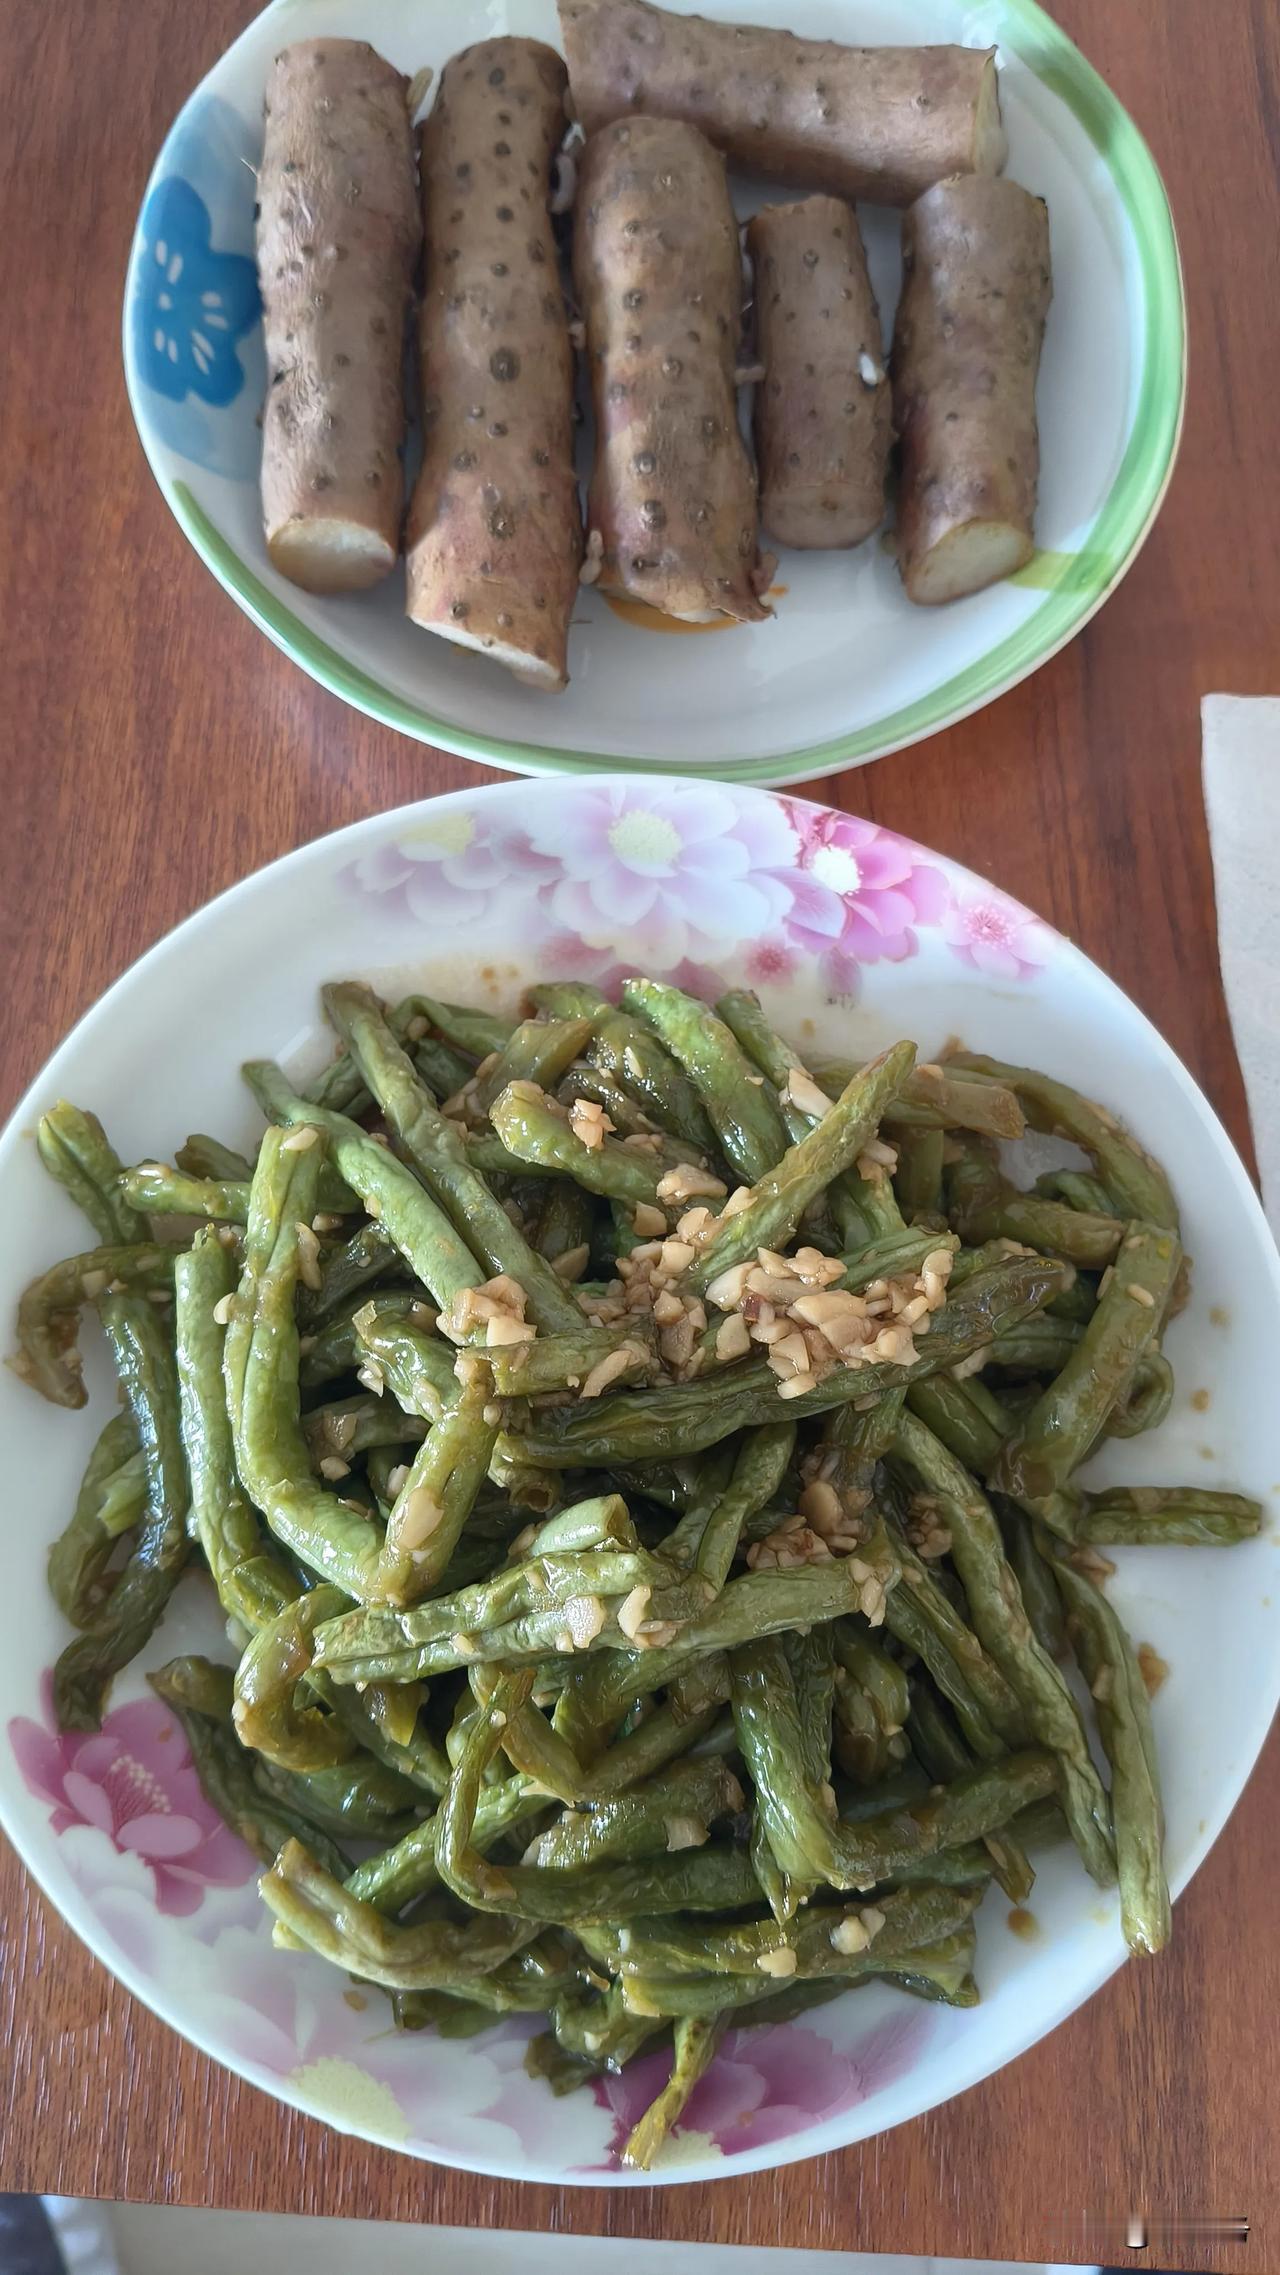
[125,0,1187,783]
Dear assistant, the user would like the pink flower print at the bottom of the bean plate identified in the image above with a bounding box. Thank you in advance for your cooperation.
[593,2007,930,2161]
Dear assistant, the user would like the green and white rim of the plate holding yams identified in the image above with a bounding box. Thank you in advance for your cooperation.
[123,0,1187,789]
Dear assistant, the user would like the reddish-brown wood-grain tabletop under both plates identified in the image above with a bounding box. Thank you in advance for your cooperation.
[0,0,1280,2270]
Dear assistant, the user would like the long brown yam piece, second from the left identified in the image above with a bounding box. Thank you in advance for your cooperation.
[407,39,582,687]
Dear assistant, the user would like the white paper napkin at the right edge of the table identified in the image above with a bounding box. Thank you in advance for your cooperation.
[1200,696,1280,1240]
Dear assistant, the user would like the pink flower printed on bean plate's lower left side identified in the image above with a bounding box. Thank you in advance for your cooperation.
[9,1674,257,1913]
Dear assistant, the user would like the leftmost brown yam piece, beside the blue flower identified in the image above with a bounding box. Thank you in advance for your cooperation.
[257,39,421,592]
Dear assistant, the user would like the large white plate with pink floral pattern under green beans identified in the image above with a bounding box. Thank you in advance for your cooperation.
[0,776,1280,2186]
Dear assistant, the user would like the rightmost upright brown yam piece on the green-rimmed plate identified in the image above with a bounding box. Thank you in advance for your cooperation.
[891,175,1053,605]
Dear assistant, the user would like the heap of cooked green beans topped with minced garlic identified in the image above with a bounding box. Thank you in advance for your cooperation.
[11,978,1262,2168]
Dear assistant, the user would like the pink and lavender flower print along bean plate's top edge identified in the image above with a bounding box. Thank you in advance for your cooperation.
[346,778,1053,996]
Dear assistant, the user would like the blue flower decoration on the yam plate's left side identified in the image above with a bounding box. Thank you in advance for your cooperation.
[134,175,261,405]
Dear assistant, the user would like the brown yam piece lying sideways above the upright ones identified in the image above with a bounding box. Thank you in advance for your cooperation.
[559,0,1007,205]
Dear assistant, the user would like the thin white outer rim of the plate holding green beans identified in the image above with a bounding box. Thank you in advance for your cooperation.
[0,769,1280,2189]
